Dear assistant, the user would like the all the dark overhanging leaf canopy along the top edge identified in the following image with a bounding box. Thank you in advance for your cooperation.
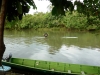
[0,0,100,21]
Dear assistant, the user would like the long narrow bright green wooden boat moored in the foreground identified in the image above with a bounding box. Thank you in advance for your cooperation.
[2,58,100,75]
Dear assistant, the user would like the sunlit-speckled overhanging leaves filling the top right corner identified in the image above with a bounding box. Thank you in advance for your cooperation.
[74,0,100,19]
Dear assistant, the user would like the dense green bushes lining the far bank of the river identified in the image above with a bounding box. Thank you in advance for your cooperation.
[5,11,100,31]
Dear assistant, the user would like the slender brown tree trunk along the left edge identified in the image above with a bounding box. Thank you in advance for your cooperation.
[0,0,7,66]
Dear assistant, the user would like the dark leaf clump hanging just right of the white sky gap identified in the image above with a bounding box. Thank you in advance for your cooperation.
[50,0,74,16]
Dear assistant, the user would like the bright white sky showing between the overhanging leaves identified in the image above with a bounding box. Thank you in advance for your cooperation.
[28,0,83,14]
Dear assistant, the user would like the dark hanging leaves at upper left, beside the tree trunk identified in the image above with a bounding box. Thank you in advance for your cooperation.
[0,0,36,21]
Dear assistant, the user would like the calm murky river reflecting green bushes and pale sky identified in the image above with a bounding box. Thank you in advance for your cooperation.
[4,30,100,66]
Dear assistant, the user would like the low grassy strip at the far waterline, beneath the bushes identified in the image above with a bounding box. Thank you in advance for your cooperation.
[5,27,100,32]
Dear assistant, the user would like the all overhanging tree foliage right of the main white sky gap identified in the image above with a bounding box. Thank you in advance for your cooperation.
[50,0,100,19]
